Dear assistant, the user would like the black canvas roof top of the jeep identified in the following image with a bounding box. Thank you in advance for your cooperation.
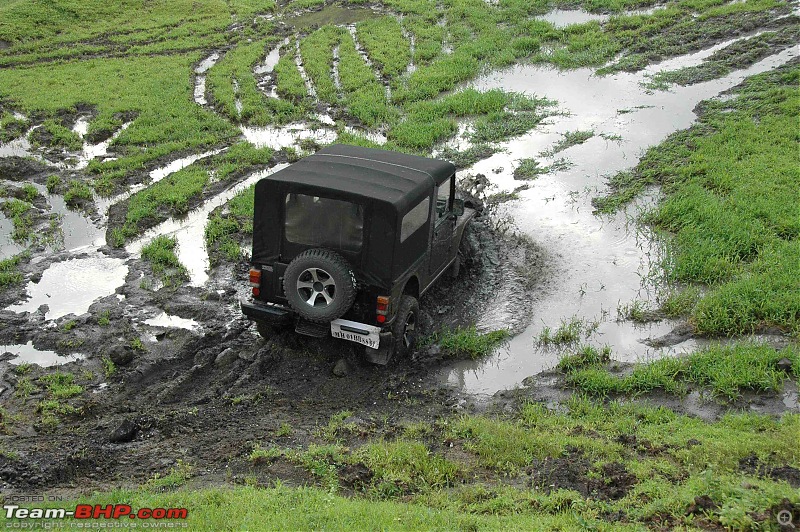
[265,144,456,212]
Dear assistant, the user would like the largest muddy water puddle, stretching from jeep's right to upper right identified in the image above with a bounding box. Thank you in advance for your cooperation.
[439,46,796,394]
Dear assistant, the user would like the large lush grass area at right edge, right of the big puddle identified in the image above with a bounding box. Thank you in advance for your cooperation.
[594,65,800,335]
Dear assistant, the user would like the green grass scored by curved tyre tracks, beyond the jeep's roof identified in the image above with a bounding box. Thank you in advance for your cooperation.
[0,0,796,241]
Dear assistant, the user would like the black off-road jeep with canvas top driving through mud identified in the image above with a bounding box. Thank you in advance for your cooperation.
[241,145,475,364]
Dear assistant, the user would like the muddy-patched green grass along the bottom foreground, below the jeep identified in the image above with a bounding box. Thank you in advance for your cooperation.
[28,397,800,530]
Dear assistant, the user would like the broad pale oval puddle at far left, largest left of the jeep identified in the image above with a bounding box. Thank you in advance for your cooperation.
[8,252,128,320]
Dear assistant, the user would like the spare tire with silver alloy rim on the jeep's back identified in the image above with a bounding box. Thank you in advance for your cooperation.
[283,249,356,322]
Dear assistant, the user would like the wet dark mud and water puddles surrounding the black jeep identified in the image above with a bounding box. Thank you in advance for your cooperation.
[0,6,798,500]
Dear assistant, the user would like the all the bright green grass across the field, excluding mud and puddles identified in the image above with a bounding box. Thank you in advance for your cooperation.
[0,0,800,530]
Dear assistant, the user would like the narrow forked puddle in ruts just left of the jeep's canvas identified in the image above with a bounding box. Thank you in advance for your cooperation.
[130,164,288,286]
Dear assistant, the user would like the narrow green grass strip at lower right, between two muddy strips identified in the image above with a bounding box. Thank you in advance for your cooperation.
[558,343,800,401]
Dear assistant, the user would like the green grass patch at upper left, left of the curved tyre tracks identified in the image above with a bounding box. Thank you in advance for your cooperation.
[0,54,237,192]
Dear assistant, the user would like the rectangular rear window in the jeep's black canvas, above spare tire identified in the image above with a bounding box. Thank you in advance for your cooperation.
[285,194,364,251]
